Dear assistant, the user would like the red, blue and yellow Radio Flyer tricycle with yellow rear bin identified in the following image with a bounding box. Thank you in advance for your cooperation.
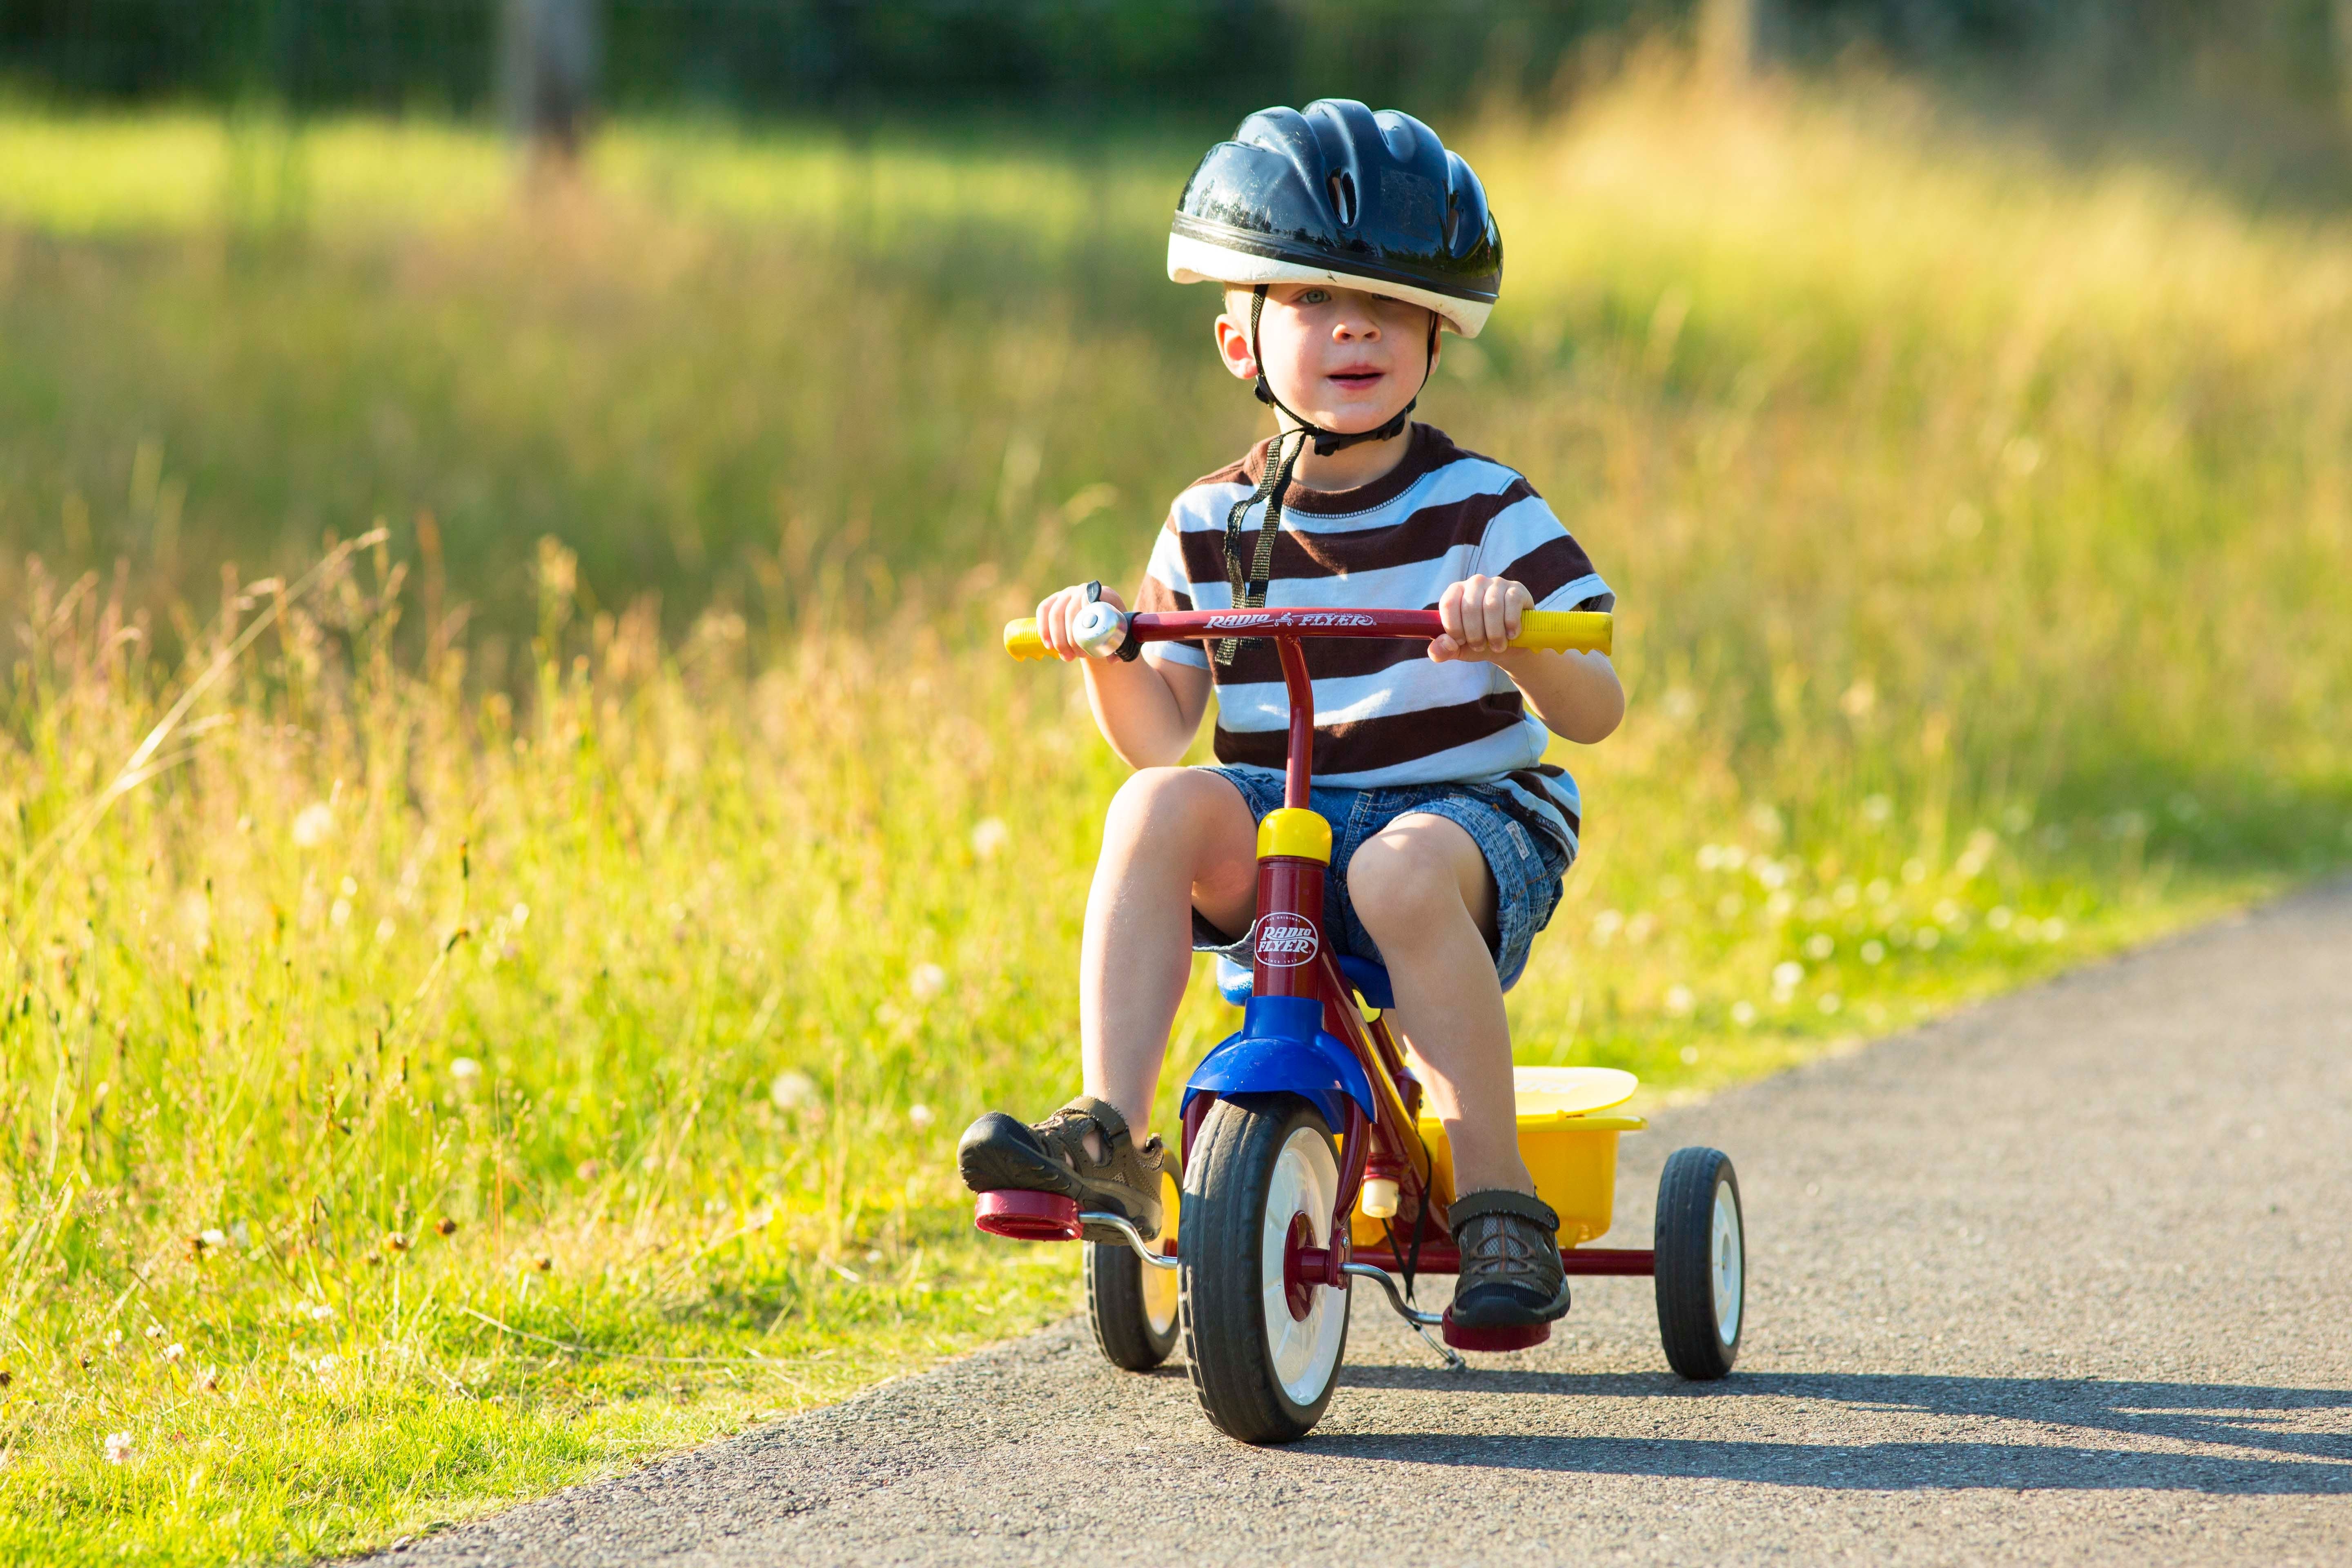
[976,602,1745,1443]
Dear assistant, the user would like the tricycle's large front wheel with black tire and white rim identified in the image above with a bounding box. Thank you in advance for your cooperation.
[1176,1100,1348,1443]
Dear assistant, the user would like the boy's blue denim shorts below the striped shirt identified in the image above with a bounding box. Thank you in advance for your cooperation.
[1192,766,1573,990]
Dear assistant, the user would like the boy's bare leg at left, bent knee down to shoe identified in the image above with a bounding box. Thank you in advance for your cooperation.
[1077,769,1270,1152]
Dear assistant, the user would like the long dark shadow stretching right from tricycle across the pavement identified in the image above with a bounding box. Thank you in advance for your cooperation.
[1308,1366,2352,1497]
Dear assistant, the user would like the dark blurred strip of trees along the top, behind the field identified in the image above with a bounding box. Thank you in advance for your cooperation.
[0,0,2352,129]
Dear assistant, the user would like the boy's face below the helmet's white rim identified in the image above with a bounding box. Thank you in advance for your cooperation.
[1216,282,1437,435]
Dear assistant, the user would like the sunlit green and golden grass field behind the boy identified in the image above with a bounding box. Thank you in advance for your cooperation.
[0,82,2352,1563]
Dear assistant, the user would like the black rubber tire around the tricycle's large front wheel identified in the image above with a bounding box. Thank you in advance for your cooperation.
[1176,1098,1350,1443]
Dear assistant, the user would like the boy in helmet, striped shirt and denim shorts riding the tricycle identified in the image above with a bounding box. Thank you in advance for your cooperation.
[960,99,1625,1326]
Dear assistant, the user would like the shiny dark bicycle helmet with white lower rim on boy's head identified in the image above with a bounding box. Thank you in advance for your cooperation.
[1169,99,1503,339]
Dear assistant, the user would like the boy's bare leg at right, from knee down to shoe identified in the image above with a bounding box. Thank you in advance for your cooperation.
[1348,811,1536,1192]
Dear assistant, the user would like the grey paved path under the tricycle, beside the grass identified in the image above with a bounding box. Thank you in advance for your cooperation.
[381,889,2352,1568]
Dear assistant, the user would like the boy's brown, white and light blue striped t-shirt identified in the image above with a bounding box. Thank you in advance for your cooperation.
[1136,423,1616,853]
